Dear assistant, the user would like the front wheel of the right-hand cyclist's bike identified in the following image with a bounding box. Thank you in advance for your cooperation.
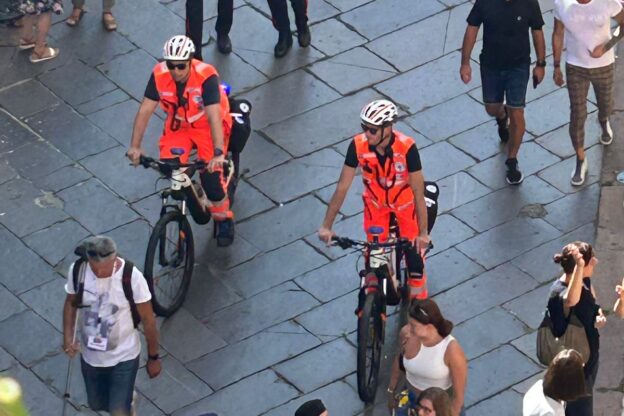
[357,293,383,403]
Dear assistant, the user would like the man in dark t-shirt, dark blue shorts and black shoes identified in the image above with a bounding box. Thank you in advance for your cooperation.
[459,0,546,185]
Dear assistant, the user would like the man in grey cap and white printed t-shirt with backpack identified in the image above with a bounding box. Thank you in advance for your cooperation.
[63,236,161,416]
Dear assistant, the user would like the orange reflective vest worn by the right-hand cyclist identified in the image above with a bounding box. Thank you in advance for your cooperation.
[354,131,415,210]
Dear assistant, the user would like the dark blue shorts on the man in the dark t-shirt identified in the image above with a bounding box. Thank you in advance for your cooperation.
[481,64,530,108]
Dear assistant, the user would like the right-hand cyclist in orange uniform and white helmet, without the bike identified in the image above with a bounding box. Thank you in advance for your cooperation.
[318,100,429,299]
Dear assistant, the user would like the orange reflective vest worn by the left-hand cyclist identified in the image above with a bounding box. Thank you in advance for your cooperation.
[154,59,232,134]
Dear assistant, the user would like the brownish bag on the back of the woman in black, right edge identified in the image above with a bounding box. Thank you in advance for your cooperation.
[536,309,589,366]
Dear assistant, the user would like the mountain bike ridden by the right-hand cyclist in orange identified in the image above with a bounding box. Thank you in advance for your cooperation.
[332,182,439,403]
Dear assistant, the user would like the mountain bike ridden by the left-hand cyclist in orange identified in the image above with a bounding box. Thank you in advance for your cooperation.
[140,148,237,317]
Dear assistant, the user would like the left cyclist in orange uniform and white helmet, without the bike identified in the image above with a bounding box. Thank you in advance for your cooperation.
[127,35,234,246]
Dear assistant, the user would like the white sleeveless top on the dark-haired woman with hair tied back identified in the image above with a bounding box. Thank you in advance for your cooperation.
[403,335,455,391]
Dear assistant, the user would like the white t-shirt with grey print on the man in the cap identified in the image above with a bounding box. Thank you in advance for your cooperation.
[65,258,152,367]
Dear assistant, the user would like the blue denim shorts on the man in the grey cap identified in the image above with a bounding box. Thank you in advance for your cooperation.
[81,356,139,416]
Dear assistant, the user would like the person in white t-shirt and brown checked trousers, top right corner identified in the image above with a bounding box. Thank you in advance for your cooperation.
[552,0,624,186]
